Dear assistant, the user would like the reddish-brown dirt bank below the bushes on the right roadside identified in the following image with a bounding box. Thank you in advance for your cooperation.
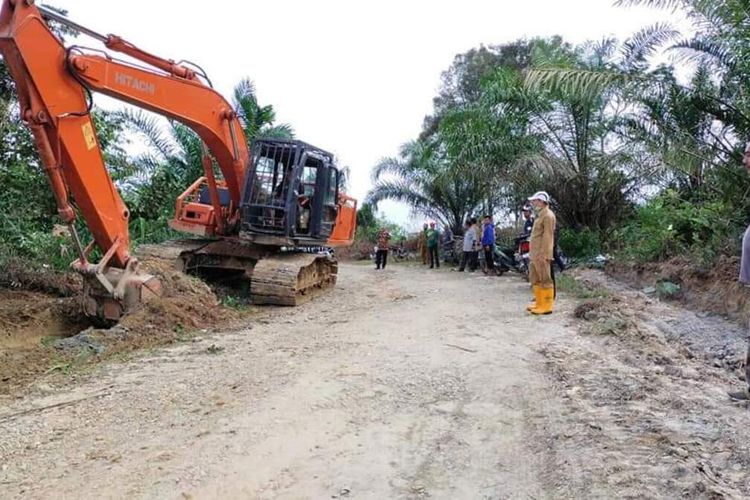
[605,257,750,321]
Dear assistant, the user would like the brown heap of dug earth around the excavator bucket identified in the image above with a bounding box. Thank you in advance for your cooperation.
[0,260,251,395]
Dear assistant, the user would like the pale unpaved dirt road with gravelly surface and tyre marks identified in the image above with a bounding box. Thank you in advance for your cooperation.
[0,265,750,499]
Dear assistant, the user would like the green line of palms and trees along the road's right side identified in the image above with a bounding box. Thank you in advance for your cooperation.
[367,0,750,259]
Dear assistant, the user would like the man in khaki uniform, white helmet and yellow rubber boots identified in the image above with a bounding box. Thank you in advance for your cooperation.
[529,191,557,314]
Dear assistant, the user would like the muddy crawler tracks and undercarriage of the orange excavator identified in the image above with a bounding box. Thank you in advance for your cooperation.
[138,239,338,306]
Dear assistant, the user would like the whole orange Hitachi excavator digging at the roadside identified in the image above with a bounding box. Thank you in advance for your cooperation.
[0,0,357,321]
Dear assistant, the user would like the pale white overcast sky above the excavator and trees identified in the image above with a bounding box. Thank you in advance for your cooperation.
[44,0,680,228]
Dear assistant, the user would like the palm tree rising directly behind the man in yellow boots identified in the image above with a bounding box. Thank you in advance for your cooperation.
[484,40,652,231]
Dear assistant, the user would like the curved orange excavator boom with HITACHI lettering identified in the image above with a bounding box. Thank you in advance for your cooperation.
[40,1,249,236]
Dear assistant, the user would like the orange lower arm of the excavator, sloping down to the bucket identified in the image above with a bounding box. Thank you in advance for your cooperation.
[0,0,130,268]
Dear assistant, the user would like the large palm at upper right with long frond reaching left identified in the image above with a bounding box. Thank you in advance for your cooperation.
[527,21,746,202]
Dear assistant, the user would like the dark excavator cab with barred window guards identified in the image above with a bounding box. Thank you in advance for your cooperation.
[240,139,340,246]
